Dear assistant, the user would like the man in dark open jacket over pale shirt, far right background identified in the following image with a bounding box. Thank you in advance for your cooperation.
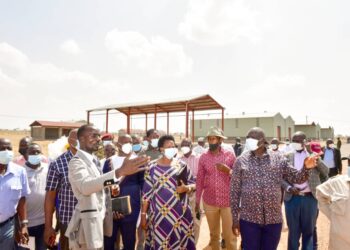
[322,139,342,177]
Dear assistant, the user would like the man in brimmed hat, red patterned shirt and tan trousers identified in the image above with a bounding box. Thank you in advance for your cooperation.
[196,127,237,250]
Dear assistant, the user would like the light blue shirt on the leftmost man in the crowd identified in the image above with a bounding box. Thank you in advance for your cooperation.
[0,162,30,223]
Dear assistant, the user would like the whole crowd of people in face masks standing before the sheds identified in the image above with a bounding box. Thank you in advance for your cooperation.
[0,125,349,250]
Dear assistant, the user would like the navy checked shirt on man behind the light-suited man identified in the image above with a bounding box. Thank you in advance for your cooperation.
[46,150,77,225]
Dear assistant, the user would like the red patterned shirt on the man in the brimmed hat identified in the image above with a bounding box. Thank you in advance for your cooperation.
[196,148,236,207]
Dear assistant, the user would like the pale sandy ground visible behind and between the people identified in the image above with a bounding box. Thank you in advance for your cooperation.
[0,130,350,250]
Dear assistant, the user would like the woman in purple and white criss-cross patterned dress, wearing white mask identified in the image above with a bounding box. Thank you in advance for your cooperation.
[141,135,196,250]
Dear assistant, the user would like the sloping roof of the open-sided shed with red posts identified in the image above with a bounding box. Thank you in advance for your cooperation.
[87,95,224,115]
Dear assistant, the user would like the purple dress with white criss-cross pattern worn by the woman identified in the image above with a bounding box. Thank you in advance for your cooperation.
[142,160,196,250]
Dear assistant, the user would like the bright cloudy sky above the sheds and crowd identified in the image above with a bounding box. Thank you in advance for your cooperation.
[0,0,350,135]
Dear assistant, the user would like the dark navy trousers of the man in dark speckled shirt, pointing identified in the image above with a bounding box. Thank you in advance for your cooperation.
[239,220,282,250]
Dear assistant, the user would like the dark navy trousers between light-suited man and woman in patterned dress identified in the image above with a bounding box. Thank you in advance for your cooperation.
[104,219,137,250]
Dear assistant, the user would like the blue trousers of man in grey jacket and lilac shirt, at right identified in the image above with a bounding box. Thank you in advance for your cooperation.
[284,195,317,250]
